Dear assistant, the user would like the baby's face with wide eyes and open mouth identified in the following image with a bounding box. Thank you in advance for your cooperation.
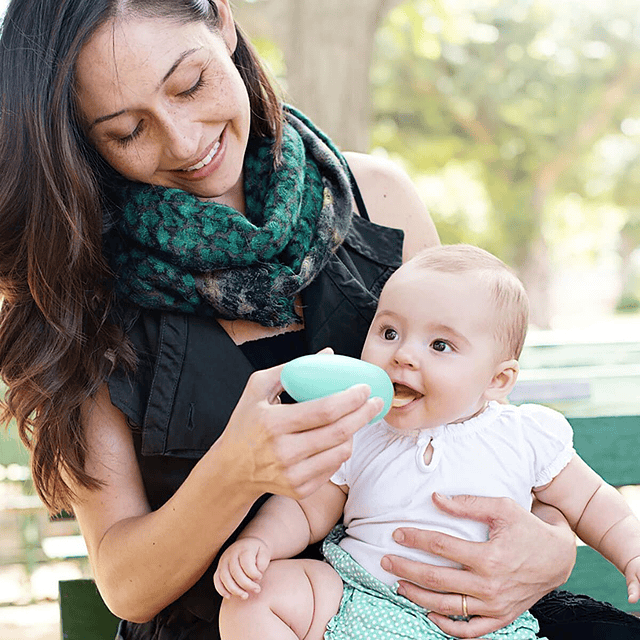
[362,265,500,429]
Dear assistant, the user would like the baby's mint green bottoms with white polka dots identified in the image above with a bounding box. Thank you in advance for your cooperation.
[322,526,546,640]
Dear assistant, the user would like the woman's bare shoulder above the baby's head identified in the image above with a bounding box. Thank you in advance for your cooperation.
[344,152,440,261]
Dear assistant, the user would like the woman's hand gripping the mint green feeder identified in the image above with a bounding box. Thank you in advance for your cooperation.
[214,356,383,499]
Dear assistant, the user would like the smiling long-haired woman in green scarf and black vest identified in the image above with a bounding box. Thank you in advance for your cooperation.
[0,0,624,640]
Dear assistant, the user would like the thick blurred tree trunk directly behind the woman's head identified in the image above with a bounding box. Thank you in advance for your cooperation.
[236,0,400,151]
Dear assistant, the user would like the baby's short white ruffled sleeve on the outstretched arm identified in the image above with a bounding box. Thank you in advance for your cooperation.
[520,404,575,488]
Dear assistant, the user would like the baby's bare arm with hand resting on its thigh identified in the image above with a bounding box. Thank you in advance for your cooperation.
[213,482,346,598]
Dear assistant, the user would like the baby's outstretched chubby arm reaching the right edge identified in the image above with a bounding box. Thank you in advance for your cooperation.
[534,455,640,602]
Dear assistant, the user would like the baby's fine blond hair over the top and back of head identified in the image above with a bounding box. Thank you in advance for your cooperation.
[407,244,529,360]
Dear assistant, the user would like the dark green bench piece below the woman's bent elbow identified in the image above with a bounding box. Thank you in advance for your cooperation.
[60,580,119,640]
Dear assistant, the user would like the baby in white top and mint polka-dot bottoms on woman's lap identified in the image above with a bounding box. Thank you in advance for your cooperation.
[214,245,640,640]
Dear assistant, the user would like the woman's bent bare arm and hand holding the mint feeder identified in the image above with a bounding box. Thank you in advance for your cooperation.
[73,367,382,622]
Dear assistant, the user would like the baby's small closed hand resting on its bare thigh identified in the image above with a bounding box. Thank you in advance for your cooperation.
[213,538,271,600]
